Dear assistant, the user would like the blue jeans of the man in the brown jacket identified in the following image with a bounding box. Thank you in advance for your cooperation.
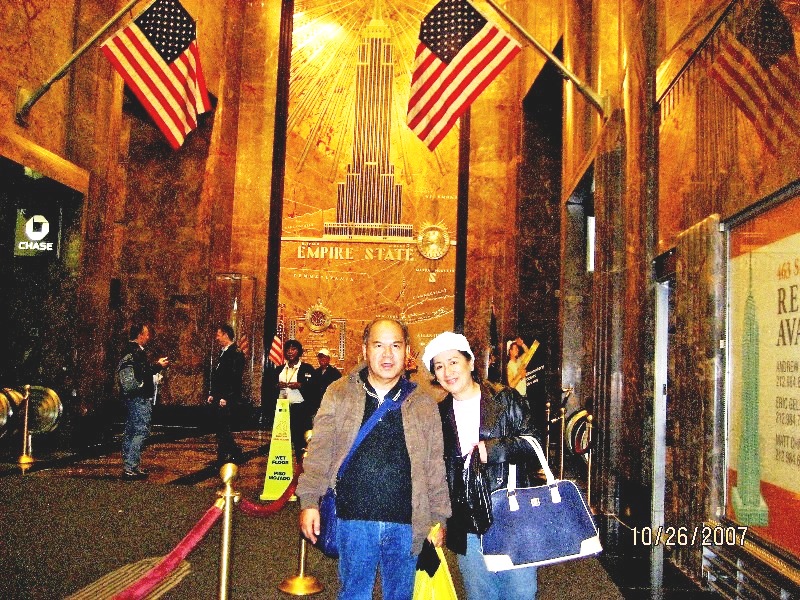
[336,520,417,600]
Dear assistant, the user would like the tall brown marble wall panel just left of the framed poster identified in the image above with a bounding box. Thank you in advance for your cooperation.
[666,215,726,574]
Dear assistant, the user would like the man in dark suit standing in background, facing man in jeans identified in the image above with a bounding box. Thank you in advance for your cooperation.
[208,324,244,463]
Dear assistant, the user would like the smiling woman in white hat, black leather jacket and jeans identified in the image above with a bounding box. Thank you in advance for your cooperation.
[422,331,539,600]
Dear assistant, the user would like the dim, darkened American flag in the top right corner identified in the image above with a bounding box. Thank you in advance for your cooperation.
[709,0,800,155]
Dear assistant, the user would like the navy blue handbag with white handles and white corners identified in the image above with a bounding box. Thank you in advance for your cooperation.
[482,436,603,571]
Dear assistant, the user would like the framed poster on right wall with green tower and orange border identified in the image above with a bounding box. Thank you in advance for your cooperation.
[726,184,800,555]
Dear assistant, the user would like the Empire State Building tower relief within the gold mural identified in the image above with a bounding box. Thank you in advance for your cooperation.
[325,16,413,238]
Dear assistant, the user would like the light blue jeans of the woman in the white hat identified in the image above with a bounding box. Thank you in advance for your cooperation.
[458,533,537,600]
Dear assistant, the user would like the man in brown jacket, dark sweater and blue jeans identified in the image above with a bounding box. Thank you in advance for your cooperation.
[296,319,450,600]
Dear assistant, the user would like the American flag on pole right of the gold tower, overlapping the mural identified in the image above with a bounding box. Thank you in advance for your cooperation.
[408,0,521,150]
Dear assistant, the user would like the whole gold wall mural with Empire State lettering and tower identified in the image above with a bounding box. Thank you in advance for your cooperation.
[278,0,458,370]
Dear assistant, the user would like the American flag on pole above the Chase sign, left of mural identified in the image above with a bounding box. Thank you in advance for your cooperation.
[101,0,211,150]
